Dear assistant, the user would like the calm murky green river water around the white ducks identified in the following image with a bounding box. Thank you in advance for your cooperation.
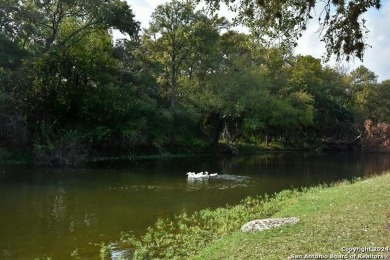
[0,154,390,259]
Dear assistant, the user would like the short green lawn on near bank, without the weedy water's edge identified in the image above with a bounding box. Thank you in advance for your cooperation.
[193,174,390,259]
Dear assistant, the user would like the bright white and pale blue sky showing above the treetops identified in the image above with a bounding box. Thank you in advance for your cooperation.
[127,0,390,82]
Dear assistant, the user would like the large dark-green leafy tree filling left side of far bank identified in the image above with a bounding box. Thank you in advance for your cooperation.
[0,0,161,163]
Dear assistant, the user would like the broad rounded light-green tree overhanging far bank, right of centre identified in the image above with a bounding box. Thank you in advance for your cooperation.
[197,31,313,144]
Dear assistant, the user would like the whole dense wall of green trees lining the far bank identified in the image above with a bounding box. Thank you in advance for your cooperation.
[0,0,390,164]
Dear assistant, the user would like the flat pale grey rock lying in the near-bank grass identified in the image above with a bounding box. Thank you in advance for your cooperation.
[241,217,299,232]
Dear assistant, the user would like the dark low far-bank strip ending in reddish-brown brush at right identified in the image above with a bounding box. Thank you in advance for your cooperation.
[0,120,390,166]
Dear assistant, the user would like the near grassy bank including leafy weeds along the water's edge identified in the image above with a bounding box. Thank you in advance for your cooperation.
[100,172,390,259]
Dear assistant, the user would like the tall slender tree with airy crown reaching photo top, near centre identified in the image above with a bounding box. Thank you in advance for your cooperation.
[143,0,204,107]
